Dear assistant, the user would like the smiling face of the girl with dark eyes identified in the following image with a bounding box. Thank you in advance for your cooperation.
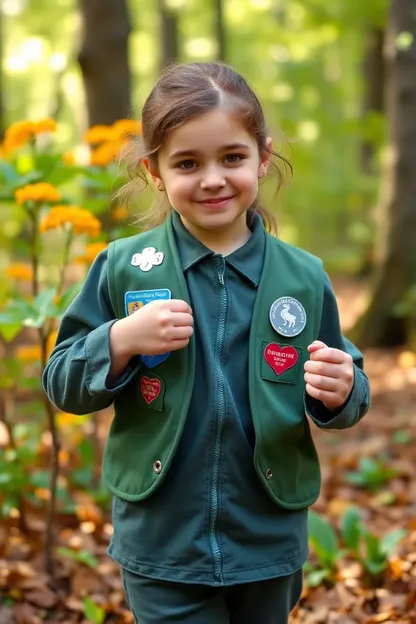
[154,108,271,244]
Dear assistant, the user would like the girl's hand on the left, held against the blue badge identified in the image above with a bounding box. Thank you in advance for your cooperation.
[110,299,194,358]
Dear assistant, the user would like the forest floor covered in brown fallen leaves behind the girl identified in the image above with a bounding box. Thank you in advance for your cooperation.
[0,281,416,624]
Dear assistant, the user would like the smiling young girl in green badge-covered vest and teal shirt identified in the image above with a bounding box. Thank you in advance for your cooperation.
[44,63,369,624]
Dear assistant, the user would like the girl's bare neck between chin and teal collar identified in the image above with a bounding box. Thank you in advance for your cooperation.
[181,216,252,256]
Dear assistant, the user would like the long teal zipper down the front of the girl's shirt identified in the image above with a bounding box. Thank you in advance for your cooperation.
[209,256,228,585]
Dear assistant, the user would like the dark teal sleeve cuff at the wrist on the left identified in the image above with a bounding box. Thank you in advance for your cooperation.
[85,320,140,395]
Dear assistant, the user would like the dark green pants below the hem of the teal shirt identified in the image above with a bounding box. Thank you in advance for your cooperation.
[122,569,302,624]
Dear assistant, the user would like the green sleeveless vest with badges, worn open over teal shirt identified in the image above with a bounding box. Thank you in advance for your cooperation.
[103,219,324,509]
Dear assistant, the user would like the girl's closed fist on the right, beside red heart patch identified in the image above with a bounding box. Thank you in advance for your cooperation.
[304,340,354,410]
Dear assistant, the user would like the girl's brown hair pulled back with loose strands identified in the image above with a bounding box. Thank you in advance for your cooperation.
[116,63,292,233]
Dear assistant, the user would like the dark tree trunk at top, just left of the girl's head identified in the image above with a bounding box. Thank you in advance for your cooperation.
[78,0,131,126]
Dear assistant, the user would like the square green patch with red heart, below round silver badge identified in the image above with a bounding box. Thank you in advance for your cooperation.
[260,341,303,384]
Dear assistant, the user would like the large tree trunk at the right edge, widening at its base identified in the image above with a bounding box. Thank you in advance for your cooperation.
[352,0,416,348]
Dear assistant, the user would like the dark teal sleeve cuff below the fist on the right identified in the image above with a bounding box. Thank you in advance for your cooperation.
[304,366,369,429]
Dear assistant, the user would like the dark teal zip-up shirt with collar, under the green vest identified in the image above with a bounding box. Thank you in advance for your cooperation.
[45,213,368,585]
